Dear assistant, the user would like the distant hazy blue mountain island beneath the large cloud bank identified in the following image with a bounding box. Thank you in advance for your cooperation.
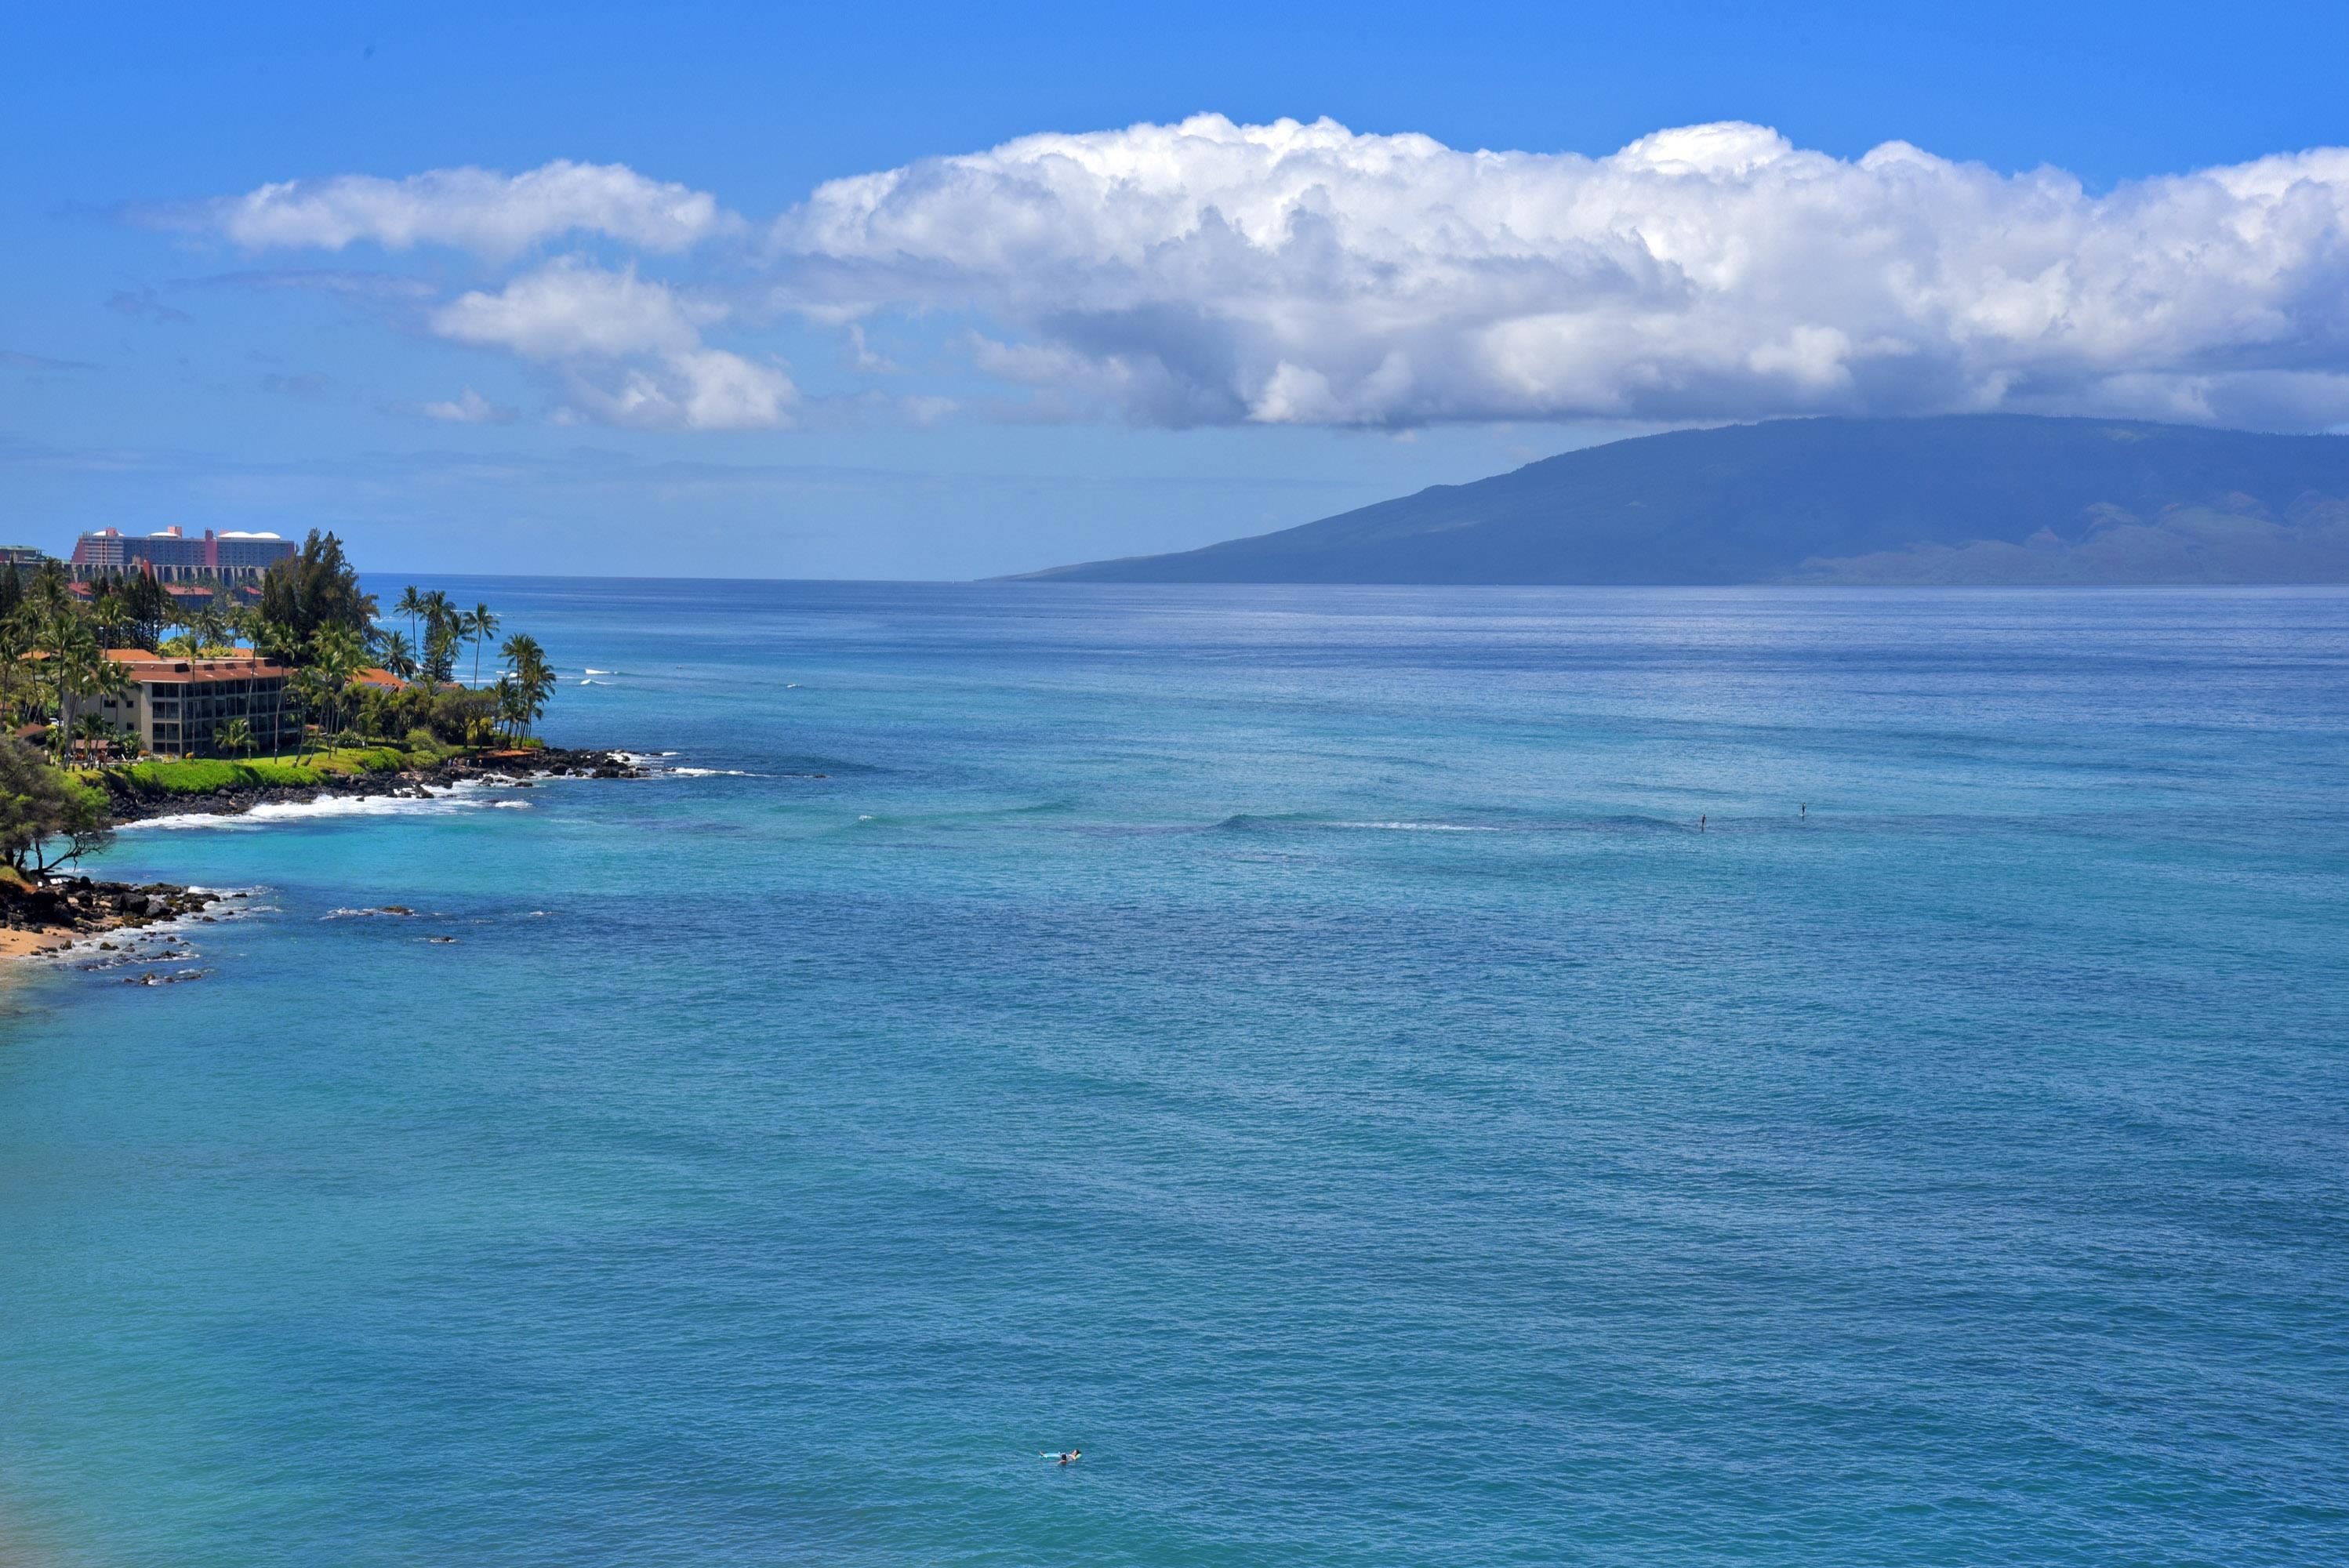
[1031,413,2349,585]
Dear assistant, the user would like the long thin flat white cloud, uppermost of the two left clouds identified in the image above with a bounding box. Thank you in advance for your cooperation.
[199,160,740,256]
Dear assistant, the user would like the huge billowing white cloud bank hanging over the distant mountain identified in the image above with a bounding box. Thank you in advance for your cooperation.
[771,115,2349,427]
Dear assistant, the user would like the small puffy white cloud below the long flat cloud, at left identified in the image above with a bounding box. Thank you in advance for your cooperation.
[430,258,799,430]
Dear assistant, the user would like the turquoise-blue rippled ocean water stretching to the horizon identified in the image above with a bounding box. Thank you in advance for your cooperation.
[0,583,2349,1566]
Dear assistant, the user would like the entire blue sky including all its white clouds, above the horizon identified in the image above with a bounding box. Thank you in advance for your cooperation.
[0,5,2349,578]
